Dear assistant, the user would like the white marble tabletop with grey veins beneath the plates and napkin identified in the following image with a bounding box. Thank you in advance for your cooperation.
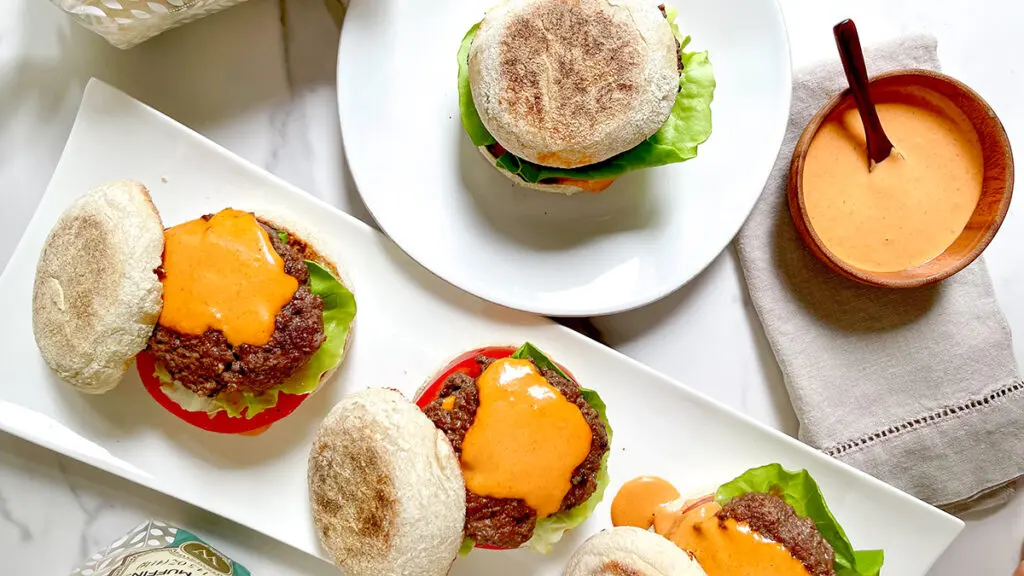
[0,0,1024,576]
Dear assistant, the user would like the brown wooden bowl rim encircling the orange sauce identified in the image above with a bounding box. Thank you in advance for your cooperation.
[787,69,1014,288]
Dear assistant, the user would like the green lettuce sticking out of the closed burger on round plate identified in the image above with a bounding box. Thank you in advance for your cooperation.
[459,8,716,182]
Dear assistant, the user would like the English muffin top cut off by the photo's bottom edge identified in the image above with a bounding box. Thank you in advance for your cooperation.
[564,526,707,576]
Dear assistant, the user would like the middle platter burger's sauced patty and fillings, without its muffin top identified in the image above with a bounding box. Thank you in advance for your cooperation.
[417,343,611,553]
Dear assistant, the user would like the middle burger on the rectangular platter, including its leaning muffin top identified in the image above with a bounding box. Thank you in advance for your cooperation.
[308,343,606,576]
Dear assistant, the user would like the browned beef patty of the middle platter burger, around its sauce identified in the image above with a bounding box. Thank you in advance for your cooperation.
[423,357,608,548]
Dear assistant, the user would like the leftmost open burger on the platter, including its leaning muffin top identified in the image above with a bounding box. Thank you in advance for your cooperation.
[33,181,355,434]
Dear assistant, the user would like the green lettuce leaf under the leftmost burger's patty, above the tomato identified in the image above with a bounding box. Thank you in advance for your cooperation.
[156,260,355,418]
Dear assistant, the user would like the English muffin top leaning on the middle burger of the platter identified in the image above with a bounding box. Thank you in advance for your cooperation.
[308,388,466,576]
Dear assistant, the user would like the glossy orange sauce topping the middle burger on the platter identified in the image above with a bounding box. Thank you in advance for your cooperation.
[462,358,592,518]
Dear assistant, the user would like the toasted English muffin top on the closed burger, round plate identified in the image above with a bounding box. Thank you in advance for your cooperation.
[469,0,680,168]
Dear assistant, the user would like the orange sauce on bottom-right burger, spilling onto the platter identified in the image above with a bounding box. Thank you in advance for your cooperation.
[611,477,809,576]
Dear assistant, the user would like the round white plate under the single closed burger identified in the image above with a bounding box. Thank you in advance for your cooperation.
[338,0,792,316]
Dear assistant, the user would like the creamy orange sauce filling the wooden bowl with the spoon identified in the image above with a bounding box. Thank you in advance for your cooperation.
[803,92,984,272]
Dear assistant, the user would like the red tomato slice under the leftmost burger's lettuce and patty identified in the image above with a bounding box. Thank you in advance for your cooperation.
[135,352,309,436]
